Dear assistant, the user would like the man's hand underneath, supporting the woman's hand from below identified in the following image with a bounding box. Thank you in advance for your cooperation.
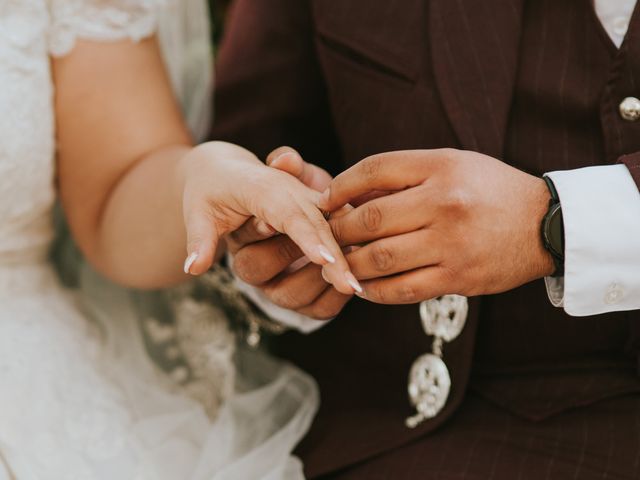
[228,147,351,319]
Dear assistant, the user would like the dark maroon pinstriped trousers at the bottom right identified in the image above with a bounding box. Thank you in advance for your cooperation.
[320,394,640,480]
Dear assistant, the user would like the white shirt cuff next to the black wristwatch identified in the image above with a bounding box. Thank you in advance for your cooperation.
[545,165,640,316]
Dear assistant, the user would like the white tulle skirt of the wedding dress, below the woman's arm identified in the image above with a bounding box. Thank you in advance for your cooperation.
[0,264,317,480]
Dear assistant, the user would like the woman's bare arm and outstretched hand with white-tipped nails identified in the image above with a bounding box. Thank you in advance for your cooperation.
[52,39,353,293]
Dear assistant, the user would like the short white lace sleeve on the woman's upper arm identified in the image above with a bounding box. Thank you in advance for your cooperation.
[49,0,176,56]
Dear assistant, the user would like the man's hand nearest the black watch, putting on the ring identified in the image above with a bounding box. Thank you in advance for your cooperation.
[320,149,554,304]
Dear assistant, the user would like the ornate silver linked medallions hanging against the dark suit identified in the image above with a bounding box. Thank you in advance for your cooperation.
[405,295,469,428]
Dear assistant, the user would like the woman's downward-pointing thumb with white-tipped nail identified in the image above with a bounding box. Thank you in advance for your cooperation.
[184,201,219,275]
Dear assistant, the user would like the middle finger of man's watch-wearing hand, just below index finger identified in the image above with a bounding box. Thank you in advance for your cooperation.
[329,185,432,245]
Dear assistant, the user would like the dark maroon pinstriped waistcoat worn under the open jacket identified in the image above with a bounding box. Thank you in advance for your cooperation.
[473,0,640,420]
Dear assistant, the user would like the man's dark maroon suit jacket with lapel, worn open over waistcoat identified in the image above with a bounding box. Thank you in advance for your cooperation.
[213,0,640,474]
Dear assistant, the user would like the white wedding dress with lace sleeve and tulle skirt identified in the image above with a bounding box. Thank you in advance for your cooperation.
[0,0,318,480]
